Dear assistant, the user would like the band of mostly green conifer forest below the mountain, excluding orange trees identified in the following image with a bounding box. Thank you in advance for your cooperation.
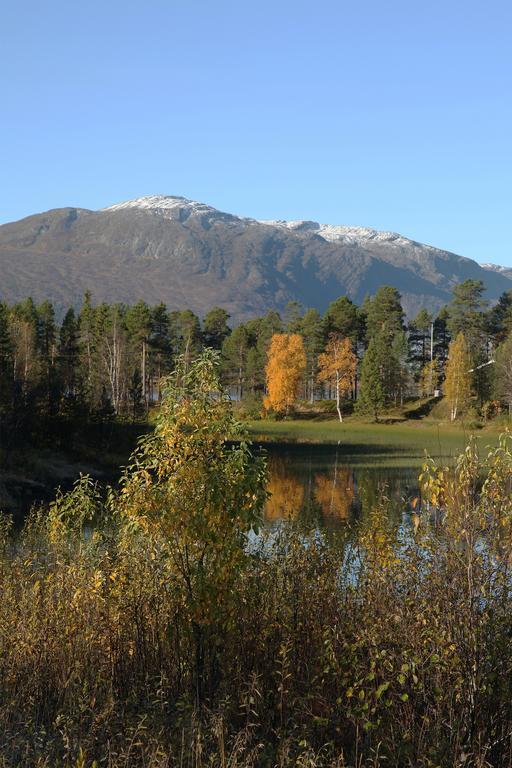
[0,280,512,434]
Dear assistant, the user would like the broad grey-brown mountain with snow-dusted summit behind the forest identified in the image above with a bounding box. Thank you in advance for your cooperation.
[0,195,512,320]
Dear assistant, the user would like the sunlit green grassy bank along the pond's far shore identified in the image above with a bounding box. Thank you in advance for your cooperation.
[249,418,499,463]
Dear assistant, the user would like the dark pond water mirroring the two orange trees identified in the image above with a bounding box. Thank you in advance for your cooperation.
[265,445,419,529]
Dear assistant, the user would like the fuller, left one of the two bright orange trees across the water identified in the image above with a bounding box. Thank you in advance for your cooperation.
[263,333,306,413]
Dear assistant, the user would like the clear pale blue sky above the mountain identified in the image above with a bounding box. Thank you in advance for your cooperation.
[0,0,512,265]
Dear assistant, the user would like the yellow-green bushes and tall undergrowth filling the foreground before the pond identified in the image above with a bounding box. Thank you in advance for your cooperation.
[0,354,512,768]
